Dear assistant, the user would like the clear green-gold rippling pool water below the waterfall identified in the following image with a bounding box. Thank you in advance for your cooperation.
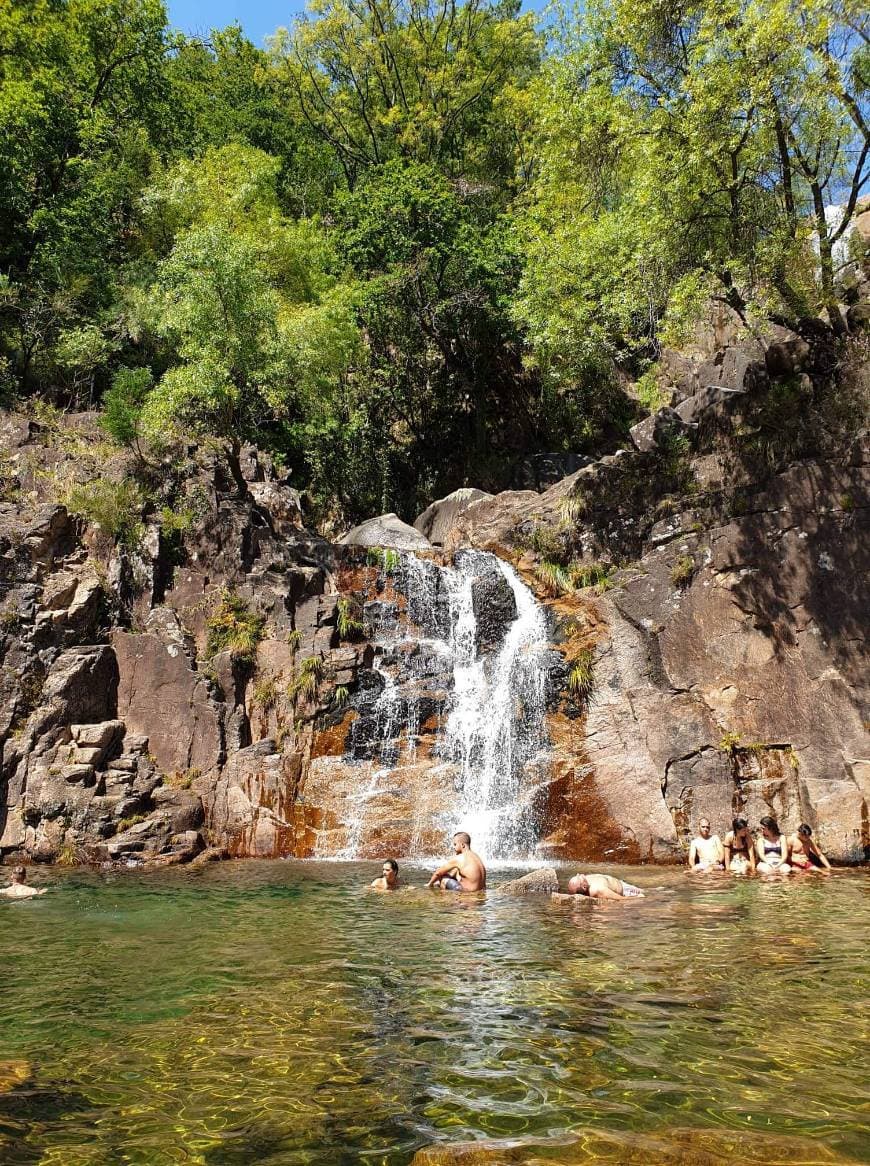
[0,862,870,1166]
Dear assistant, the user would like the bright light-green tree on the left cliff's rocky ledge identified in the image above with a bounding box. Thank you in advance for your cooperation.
[133,146,358,482]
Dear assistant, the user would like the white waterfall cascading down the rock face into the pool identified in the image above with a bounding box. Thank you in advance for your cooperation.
[343,550,550,858]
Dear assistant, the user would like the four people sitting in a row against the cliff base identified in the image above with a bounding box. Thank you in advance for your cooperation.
[689,817,830,875]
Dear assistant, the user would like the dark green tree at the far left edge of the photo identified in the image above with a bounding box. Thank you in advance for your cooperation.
[0,0,166,400]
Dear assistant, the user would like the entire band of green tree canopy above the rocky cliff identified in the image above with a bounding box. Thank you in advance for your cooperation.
[0,0,870,521]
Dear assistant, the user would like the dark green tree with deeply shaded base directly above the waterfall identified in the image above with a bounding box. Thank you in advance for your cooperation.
[326,160,533,513]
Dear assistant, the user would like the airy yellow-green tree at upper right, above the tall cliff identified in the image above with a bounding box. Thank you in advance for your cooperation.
[519,0,869,379]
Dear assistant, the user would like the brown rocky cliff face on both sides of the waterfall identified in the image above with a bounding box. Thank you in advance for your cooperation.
[0,328,870,863]
